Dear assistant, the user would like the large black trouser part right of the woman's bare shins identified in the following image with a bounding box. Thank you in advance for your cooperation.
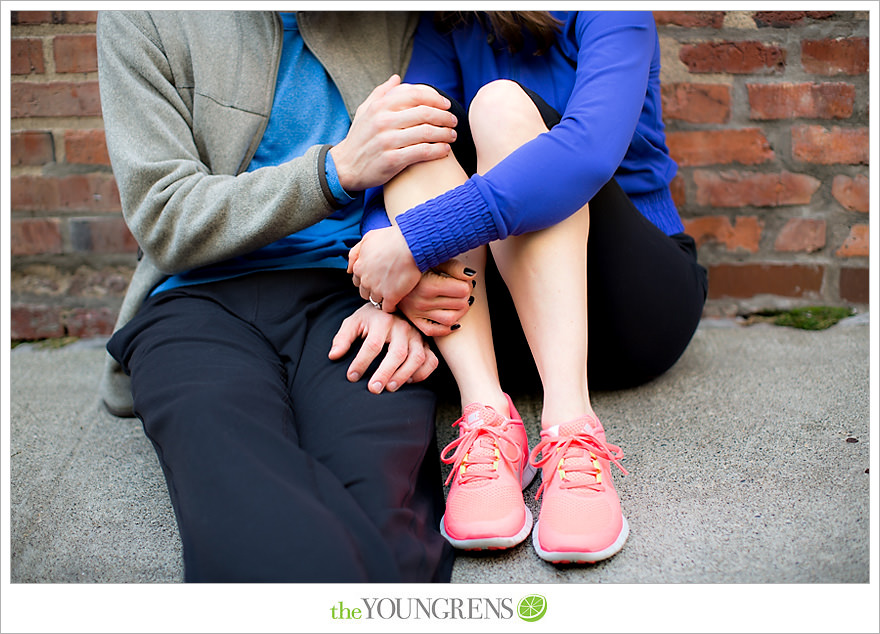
[587,180,707,389]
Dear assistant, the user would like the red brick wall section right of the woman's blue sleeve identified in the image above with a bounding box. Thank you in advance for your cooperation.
[654,11,869,316]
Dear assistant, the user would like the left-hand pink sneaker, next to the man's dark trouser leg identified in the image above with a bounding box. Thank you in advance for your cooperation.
[440,395,536,550]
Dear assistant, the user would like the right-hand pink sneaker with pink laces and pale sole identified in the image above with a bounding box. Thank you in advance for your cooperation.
[529,416,629,563]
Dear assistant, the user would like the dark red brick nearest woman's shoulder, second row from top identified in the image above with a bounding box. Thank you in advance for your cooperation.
[678,42,785,74]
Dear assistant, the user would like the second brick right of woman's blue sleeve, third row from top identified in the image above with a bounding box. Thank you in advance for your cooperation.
[747,83,856,119]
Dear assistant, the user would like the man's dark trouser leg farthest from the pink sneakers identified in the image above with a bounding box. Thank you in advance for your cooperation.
[108,280,410,582]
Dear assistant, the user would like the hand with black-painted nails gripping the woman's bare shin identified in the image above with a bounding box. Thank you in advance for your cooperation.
[397,260,476,337]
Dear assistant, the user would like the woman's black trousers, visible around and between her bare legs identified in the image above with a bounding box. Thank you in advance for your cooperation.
[435,84,708,392]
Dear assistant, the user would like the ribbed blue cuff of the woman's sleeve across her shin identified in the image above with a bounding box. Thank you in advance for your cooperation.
[397,180,506,273]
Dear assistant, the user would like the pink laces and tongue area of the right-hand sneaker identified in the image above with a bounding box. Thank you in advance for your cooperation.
[529,431,627,500]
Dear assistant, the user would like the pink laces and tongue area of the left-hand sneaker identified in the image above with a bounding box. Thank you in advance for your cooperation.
[440,416,522,484]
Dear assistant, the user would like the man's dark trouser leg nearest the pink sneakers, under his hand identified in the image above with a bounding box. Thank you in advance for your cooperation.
[254,270,453,582]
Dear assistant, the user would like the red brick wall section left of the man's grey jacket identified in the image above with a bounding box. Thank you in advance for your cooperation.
[9,11,131,339]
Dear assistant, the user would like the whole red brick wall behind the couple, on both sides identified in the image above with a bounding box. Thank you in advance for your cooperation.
[10,11,868,339]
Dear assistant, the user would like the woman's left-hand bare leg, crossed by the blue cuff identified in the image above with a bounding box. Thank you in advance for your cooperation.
[385,154,510,417]
